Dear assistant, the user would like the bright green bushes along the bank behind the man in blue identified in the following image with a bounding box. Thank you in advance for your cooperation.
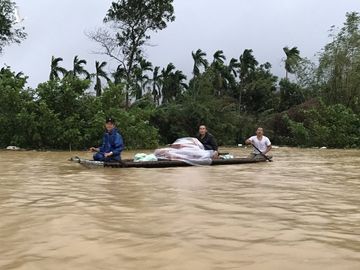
[0,68,158,149]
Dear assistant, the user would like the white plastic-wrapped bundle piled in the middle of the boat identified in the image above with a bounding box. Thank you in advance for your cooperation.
[154,137,214,165]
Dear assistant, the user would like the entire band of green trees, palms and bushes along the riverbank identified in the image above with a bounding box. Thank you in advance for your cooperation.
[0,0,360,149]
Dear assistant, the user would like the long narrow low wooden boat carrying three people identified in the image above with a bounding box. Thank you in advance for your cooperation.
[69,157,271,168]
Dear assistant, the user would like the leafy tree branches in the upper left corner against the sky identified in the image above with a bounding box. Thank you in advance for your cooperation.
[0,0,26,53]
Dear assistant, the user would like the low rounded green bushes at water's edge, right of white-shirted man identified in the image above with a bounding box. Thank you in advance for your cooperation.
[273,102,360,148]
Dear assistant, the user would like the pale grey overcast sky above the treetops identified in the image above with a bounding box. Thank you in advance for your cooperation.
[0,0,360,87]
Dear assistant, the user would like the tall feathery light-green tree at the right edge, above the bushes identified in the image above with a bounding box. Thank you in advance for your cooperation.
[317,12,360,113]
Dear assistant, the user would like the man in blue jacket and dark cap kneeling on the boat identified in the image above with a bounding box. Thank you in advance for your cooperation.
[90,118,124,162]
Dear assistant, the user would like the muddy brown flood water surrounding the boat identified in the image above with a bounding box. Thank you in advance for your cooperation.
[0,148,360,270]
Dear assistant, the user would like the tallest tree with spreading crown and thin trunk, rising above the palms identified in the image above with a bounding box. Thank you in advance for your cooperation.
[90,0,175,107]
